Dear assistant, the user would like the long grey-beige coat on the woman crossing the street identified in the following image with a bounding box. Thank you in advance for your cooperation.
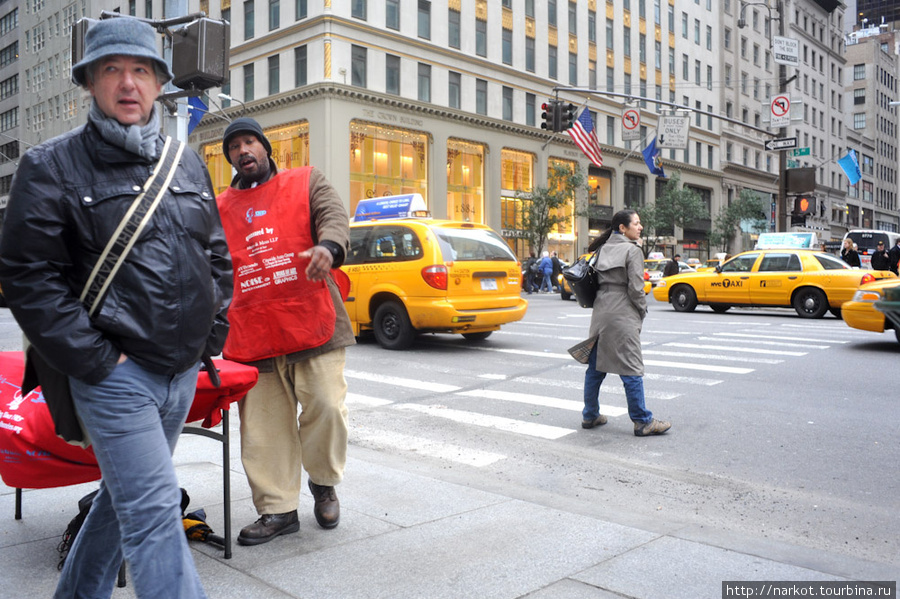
[590,233,647,376]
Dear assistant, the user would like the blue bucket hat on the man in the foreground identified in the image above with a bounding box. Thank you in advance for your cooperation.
[72,17,174,86]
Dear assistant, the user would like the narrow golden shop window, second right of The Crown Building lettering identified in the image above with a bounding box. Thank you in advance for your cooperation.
[500,150,535,260]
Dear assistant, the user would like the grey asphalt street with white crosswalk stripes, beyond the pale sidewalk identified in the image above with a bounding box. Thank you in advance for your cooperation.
[0,294,900,564]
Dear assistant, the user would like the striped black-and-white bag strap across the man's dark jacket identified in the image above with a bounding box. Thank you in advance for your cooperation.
[80,137,184,316]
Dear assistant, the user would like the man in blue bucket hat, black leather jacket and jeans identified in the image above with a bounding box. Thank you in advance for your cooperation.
[0,17,233,599]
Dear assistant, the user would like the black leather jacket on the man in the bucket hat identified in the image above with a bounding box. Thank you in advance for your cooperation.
[0,123,233,384]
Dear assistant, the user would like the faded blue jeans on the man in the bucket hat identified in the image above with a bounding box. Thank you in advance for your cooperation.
[54,360,206,599]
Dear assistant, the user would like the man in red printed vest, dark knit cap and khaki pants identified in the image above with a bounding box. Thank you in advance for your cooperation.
[216,118,355,545]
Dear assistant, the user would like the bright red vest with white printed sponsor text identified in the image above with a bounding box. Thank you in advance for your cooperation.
[216,167,335,362]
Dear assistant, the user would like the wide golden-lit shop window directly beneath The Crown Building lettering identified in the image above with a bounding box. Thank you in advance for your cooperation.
[350,121,428,214]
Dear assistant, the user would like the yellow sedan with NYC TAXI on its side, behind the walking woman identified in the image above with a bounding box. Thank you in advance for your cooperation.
[653,248,896,318]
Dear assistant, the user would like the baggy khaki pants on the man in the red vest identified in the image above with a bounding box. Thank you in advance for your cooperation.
[238,348,348,514]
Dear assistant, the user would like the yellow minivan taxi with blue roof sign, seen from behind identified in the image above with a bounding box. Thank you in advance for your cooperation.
[341,194,528,349]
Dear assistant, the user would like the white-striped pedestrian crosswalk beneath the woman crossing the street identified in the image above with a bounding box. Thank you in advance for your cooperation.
[345,319,872,468]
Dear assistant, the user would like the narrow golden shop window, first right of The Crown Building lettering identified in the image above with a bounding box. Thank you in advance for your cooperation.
[447,139,484,223]
